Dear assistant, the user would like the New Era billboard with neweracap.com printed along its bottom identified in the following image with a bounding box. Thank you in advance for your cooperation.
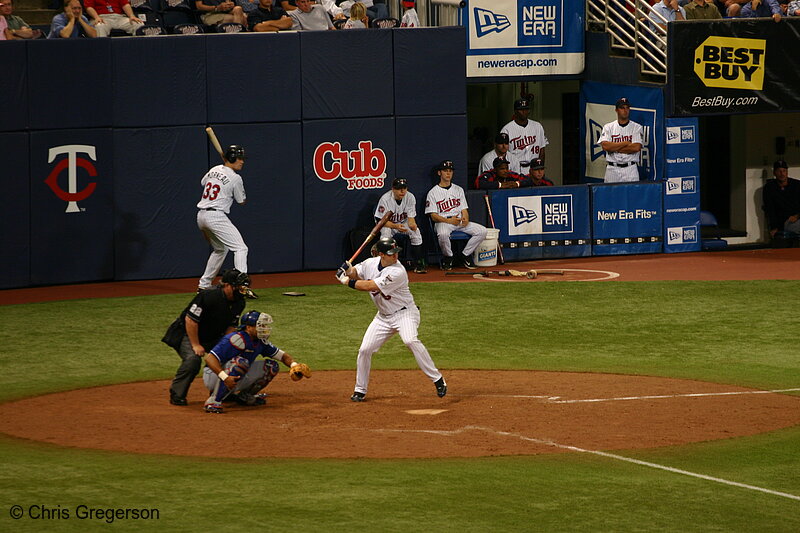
[459,0,584,78]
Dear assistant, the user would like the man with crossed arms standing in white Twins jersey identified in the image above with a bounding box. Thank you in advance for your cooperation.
[597,98,642,183]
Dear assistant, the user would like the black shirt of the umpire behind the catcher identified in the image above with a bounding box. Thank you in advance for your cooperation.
[181,287,245,352]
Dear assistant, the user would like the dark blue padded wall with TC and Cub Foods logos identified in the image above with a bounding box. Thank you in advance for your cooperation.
[0,27,467,288]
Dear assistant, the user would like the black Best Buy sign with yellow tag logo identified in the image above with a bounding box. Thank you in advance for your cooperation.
[667,17,800,116]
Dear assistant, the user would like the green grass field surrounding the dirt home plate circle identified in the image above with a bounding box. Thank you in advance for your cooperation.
[0,281,800,532]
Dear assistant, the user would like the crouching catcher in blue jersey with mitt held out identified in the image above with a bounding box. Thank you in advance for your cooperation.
[203,311,311,414]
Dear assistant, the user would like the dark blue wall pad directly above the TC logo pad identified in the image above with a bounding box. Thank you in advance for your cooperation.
[26,39,111,130]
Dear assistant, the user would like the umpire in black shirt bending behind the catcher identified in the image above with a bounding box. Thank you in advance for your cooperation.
[161,268,250,405]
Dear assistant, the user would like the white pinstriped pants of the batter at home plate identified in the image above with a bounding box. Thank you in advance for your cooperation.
[355,306,442,394]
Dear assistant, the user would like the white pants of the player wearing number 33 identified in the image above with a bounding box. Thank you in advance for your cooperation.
[197,209,247,289]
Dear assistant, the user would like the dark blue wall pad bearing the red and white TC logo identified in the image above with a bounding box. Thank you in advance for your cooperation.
[29,129,114,285]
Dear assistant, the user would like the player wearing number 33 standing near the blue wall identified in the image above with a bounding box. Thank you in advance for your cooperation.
[197,144,258,299]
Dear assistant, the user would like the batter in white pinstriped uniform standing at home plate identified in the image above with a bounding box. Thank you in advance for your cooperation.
[336,238,447,402]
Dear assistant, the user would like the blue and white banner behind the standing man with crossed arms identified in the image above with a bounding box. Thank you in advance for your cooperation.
[580,82,664,182]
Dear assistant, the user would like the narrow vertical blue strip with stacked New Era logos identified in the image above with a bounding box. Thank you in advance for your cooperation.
[664,118,700,252]
